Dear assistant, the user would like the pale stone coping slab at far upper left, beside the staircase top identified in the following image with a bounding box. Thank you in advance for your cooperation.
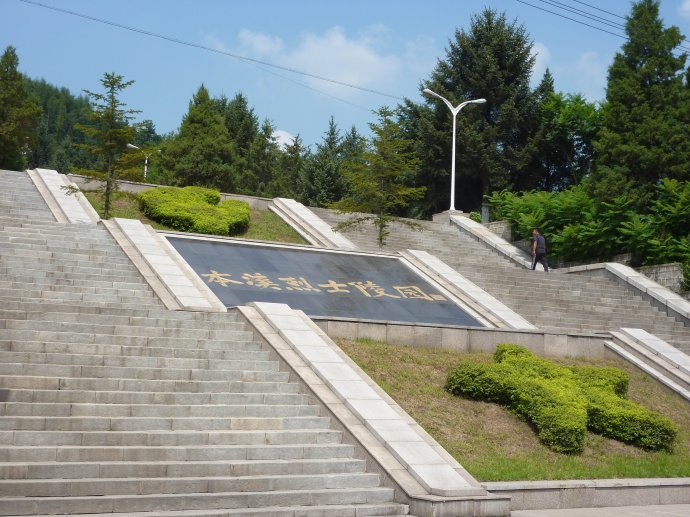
[28,169,101,224]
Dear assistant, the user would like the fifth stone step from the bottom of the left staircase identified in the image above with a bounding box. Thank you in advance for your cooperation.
[0,444,354,464]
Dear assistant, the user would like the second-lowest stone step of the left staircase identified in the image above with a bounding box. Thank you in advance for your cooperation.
[0,488,400,517]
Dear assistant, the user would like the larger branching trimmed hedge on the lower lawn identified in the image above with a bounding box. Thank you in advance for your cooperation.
[446,344,677,454]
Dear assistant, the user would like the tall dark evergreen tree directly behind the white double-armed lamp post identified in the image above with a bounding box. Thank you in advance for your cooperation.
[401,8,538,215]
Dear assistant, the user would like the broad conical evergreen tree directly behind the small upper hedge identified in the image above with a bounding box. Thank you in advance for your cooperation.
[160,85,237,192]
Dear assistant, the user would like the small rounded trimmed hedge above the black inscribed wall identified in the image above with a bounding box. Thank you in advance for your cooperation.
[139,187,249,235]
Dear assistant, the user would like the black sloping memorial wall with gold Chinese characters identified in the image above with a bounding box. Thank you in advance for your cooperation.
[167,236,482,326]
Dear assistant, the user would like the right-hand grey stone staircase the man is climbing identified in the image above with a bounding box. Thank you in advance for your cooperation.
[310,208,690,353]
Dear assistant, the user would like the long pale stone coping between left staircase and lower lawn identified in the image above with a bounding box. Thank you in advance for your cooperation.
[249,302,487,497]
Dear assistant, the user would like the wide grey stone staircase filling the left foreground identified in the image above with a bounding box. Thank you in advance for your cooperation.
[0,171,408,517]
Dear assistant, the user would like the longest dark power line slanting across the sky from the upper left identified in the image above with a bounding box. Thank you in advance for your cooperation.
[19,0,404,102]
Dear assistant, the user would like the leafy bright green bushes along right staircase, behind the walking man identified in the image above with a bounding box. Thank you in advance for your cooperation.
[487,178,690,267]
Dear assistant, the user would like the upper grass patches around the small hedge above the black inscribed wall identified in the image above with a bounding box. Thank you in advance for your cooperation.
[84,191,308,244]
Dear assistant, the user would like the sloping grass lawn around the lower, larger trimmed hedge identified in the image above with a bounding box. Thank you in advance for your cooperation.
[338,340,690,481]
